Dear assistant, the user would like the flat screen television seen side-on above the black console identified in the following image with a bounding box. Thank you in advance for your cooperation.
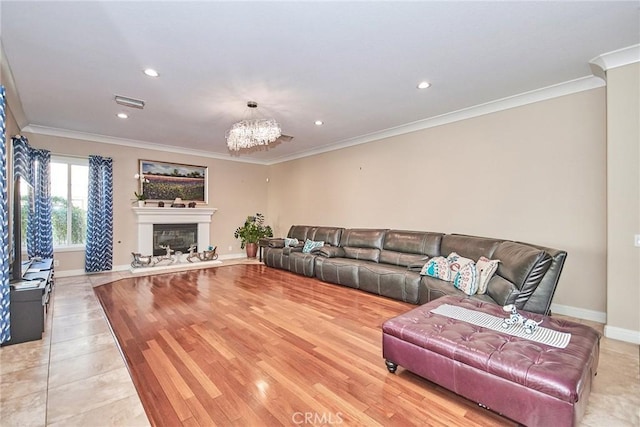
[10,175,35,281]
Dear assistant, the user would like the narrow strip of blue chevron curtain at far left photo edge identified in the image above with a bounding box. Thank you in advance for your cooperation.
[0,86,11,343]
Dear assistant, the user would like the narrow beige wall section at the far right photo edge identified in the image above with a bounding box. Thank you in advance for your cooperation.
[606,63,640,342]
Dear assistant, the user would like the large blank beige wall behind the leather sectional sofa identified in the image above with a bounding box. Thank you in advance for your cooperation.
[268,88,606,313]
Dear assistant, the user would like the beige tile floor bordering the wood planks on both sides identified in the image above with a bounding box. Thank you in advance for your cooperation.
[0,262,640,427]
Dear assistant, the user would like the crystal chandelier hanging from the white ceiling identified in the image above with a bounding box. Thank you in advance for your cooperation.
[226,101,282,151]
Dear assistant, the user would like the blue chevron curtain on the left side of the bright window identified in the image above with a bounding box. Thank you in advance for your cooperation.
[27,148,53,258]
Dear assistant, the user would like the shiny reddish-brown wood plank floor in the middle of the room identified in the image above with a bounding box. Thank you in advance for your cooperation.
[94,264,514,426]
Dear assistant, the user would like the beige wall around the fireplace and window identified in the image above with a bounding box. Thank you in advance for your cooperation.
[25,133,268,271]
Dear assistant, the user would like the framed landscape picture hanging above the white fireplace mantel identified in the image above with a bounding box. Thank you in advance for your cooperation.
[140,160,208,204]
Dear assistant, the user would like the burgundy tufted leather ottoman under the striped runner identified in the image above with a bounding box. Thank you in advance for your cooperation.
[382,296,600,426]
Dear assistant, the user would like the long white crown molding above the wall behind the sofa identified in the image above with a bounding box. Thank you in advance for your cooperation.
[268,76,605,165]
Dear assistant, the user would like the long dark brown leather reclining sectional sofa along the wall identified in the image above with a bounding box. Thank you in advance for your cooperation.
[265,225,567,314]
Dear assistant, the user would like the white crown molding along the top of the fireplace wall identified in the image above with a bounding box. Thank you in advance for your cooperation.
[22,125,266,165]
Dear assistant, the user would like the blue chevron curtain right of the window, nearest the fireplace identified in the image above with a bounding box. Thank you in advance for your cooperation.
[84,156,113,273]
